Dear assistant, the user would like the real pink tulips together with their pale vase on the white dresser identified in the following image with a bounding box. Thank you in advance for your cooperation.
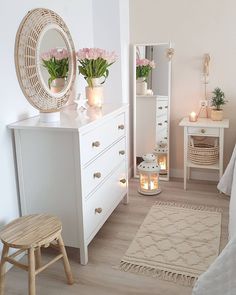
[76,48,117,107]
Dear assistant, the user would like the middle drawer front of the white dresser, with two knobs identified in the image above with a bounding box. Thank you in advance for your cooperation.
[83,137,126,196]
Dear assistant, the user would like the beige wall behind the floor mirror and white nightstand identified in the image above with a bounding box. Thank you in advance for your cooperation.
[130,0,236,180]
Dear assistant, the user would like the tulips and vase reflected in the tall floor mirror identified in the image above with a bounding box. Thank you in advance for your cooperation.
[136,58,155,95]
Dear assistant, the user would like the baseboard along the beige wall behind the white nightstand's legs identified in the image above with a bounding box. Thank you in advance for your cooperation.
[170,168,219,182]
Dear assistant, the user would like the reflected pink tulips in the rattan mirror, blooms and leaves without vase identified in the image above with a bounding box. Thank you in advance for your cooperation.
[41,48,69,88]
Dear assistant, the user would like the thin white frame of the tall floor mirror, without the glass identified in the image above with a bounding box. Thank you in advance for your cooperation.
[133,42,172,181]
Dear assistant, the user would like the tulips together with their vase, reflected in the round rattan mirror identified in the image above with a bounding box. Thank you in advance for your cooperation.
[41,48,69,93]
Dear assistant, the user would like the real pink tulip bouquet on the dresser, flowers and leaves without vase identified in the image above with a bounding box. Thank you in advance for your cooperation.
[76,48,117,87]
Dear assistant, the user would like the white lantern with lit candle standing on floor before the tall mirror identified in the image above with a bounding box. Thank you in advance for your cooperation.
[138,154,161,195]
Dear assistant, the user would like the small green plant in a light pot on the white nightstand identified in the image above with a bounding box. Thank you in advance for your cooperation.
[211,87,227,121]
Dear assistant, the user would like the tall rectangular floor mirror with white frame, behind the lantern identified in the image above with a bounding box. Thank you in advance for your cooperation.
[133,42,173,181]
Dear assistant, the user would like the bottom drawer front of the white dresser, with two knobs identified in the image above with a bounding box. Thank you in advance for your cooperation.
[84,162,127,240]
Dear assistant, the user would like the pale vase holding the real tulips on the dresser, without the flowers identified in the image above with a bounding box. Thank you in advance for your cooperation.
[85,78,104,108]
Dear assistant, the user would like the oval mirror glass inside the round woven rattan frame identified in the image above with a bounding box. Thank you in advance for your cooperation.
[39,29,69,93]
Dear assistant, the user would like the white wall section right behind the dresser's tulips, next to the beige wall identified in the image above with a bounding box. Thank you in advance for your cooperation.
[93,0,129,103]
